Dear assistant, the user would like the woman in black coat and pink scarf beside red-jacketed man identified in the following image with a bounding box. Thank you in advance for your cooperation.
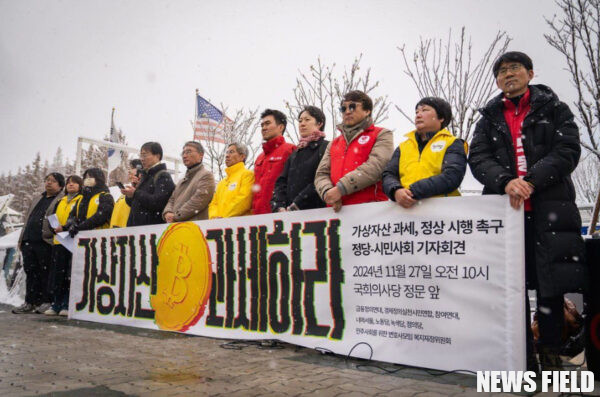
[271,106,329,212]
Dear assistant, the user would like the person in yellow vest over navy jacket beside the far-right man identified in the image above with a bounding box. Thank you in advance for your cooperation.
[383,97,467,208]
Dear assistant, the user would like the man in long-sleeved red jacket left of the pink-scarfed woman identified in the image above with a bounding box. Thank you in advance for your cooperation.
[252,109,296,215]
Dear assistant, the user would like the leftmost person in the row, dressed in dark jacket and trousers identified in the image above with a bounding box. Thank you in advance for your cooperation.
[12,172,65,314]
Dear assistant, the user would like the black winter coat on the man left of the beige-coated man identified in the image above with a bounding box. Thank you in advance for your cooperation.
[125,164,175,226]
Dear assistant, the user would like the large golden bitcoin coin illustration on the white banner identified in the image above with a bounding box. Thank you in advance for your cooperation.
[150,222,212,332]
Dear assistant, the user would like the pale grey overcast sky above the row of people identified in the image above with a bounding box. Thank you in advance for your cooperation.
[0,0,573,186]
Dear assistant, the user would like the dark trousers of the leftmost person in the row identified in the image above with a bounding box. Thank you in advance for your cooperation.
[21,241,52,306]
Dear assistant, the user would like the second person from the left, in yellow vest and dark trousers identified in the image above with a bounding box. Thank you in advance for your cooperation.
[44,175,83,316]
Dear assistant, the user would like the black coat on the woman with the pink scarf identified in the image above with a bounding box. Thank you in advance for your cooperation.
[271,138,329,212]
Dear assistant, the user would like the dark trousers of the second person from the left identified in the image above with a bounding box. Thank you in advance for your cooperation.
[50,244,73,312]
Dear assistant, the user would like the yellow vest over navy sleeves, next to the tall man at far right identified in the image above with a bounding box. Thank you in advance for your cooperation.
[398,128,467,197]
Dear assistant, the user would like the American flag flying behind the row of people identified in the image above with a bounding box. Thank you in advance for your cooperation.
[194,92,233,143]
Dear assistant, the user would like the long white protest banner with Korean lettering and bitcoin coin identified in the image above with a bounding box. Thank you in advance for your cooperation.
[69,196,525,371]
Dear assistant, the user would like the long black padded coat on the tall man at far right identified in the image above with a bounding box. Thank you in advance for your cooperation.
[469,85,587,297]
